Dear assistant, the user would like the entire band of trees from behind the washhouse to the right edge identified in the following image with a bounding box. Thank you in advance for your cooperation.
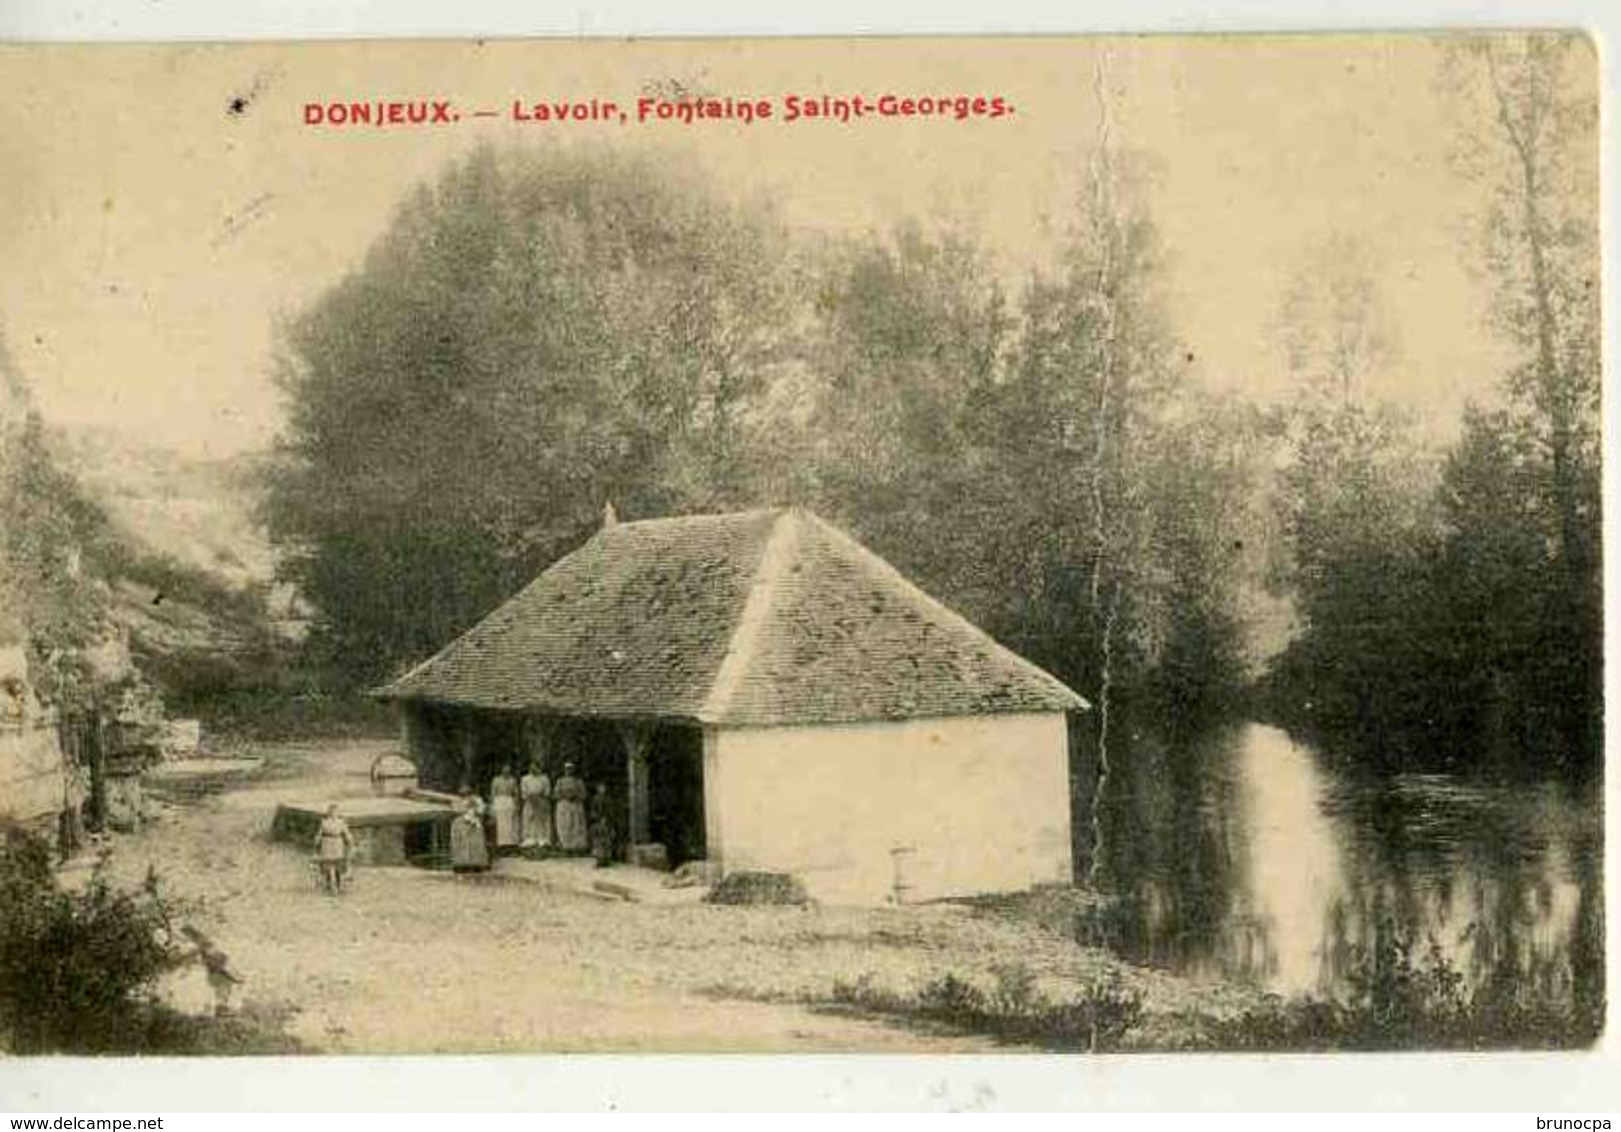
[267,37,1600,765]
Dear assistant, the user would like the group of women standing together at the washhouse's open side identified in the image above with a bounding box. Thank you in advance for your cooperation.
[451,761,606,873]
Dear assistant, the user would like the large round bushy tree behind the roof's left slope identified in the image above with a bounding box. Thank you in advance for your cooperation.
[267,148,791,681]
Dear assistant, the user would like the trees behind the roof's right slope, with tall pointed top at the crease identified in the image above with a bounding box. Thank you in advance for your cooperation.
[807,64,1209,741]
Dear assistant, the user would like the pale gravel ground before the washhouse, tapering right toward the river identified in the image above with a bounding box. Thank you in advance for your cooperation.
[94,741,1260,1053]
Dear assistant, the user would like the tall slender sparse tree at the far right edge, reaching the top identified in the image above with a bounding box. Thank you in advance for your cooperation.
[1443,34,1603,762]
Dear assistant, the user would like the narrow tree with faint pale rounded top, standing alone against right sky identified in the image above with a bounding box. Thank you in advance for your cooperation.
[1269,235,1451,761]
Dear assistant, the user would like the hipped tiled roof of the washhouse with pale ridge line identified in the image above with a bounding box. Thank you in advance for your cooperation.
[378,509,1086,727]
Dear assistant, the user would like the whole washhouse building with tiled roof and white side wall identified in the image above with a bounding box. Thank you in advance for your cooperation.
[378,509,1086,903]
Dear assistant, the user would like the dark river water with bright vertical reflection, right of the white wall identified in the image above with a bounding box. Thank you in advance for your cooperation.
[1076,725,1603,1001]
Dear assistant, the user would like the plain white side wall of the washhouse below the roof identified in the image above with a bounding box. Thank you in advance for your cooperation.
[704,712,1070,905]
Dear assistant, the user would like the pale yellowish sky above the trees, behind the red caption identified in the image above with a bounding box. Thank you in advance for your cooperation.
[0,36,1556,456]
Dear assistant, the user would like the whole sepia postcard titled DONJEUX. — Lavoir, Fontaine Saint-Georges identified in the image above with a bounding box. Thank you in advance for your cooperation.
[0,31,1606,1054]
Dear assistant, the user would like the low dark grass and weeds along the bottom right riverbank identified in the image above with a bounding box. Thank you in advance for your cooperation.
[710,889,1603,1053]
